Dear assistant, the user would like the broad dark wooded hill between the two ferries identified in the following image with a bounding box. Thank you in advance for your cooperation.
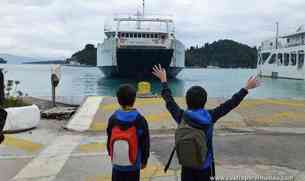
[186,40,257,68]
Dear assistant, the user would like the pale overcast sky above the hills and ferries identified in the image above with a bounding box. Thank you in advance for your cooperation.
[0,0,305,58]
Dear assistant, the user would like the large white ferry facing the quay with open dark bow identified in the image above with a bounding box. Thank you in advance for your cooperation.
[97,0,185,78]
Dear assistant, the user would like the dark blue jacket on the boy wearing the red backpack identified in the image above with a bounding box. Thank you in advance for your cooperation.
[107,109,150,171]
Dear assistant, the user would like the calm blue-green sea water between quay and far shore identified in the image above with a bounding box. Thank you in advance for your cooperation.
[0,65,305,99]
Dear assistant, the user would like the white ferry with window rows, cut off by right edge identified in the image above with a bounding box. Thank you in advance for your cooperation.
[257,24,305,80]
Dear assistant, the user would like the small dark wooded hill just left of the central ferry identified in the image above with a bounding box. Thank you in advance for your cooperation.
[67,44,97,66]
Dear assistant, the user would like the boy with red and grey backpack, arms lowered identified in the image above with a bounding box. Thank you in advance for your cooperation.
[107,84,150,181]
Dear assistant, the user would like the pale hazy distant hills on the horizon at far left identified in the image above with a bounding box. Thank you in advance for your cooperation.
[0,53,64,64]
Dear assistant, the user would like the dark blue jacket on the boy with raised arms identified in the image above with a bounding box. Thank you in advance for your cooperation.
[162,83,248,170]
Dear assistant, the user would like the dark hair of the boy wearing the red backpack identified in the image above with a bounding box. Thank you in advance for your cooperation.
[116,84,137,106]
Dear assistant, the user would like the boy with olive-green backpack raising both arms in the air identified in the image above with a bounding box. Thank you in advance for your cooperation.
[153,65,260,181]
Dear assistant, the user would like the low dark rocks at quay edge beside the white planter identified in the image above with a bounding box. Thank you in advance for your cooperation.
[41,107,77,120]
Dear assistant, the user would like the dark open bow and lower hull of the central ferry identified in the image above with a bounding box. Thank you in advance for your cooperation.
[100,48,182,79]
